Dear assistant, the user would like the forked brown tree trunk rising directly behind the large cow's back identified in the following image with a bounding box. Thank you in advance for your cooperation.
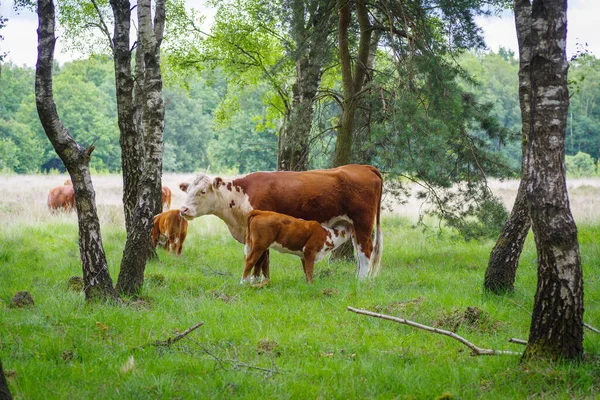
[333,0,373,167]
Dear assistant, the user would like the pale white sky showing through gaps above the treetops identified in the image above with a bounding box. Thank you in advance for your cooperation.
[0,0,600,66]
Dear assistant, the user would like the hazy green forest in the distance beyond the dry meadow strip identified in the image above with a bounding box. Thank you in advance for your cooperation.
[0,49,600,177]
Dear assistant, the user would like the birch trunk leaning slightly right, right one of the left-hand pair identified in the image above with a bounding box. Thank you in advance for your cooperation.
[115,0,165,295]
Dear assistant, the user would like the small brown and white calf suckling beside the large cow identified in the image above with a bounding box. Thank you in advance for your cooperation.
[241,210,350,283]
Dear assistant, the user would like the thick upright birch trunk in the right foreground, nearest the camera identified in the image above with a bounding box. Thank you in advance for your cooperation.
[514,0,583,360]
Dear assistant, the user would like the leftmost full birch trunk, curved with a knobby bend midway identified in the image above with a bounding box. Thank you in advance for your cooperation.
[35,0,118,300]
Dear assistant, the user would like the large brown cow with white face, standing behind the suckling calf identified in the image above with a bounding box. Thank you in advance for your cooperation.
[179,164,383,279]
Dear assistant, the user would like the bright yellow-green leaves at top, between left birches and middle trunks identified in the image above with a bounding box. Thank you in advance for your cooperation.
[166,0,293,130]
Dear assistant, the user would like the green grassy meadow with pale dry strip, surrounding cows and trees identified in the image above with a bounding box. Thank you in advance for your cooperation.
[0,175,600,400]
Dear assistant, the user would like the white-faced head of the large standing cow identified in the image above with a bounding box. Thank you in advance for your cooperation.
[179,174,223,220]
